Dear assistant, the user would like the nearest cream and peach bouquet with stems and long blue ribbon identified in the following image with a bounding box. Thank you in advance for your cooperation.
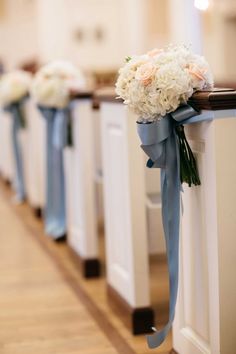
[116,46,213,348]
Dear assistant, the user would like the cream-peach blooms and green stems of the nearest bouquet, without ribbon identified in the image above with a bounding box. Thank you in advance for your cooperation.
[116,45,213,186]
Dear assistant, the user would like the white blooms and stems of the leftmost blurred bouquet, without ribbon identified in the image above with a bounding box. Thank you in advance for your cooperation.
[0,70,32,128]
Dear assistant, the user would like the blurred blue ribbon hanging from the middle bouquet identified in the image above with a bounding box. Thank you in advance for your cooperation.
[38,106,69,239]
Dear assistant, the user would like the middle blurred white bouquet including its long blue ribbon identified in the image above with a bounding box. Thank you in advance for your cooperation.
[31,61,85,239]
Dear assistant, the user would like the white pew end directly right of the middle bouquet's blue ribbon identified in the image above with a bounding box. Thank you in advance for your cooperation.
[65,99,99,276]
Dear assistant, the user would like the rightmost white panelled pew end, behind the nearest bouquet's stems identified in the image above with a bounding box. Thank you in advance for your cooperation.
[173,112,236,354]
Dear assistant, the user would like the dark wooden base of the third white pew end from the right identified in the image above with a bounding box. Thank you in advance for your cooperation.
[68,246,101,279]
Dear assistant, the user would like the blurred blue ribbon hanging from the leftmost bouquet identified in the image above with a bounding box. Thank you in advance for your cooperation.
[4,99,26,201]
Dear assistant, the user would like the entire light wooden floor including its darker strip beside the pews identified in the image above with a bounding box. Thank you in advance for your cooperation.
[0,182,171,354]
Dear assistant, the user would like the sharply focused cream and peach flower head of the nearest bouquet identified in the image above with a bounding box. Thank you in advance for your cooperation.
[116,46,213,121]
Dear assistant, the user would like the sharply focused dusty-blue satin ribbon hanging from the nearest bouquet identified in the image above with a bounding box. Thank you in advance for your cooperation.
[137,105,198,348]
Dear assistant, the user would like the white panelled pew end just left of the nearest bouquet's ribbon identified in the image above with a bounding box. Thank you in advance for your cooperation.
[101,102,150,308]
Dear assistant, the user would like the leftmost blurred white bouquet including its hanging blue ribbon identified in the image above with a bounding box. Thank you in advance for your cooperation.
[0,70,31,202]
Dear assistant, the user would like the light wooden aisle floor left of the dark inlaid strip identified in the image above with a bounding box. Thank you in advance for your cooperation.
[0,185,118,354]
